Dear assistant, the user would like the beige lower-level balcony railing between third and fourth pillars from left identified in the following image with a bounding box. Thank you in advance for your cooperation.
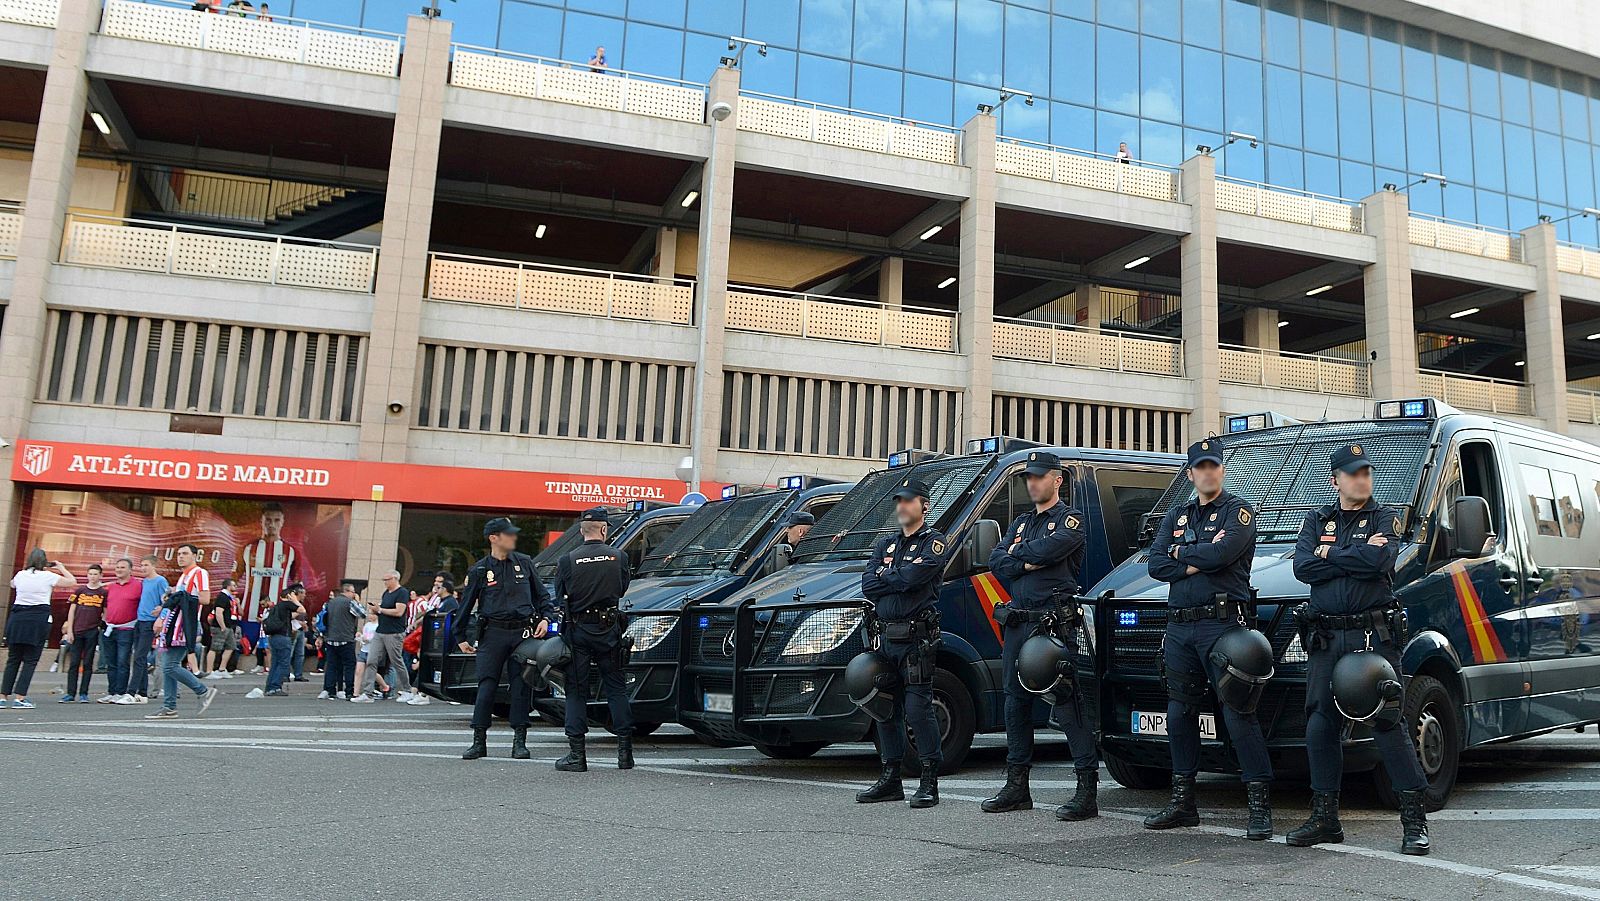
[728,285,955,354]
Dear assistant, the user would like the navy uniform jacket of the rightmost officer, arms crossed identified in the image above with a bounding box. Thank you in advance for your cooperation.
[1294,499,1400,616]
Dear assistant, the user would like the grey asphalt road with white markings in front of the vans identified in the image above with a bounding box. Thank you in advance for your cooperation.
[0,674,1600,901]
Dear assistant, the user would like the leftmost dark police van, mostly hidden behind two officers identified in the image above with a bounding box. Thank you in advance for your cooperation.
[416,501,696,704]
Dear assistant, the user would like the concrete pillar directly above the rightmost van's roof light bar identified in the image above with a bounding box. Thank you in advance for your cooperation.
[1362,190,1419,397]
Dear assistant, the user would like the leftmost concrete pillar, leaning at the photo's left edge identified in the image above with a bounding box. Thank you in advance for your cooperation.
[0,0,101,619]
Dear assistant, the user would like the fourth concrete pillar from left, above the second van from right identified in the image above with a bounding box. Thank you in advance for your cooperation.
[955,112,995,450]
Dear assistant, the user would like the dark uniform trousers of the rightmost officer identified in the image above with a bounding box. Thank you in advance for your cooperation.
[1306,629,1427,792]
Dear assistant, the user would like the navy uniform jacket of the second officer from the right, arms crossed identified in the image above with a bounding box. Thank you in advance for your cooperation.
[1147,491,1256,607]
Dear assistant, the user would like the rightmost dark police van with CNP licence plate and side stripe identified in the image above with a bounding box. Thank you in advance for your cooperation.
[1090,398,1600,808]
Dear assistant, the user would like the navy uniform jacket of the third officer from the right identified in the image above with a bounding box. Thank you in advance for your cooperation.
[989,501,1083,610]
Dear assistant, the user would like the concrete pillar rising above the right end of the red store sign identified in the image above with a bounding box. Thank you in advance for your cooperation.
[690,67,739,485]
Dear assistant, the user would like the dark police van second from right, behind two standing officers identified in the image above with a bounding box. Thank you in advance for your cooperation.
[678,437,1182,771]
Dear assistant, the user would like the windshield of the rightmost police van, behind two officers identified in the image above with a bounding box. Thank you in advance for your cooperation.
[1141,419,1434,544]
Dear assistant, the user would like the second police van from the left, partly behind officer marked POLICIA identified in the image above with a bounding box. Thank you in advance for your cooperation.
[534,475,850,735]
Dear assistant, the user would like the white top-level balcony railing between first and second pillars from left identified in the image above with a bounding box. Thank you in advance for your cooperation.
[100,0,402,75]
